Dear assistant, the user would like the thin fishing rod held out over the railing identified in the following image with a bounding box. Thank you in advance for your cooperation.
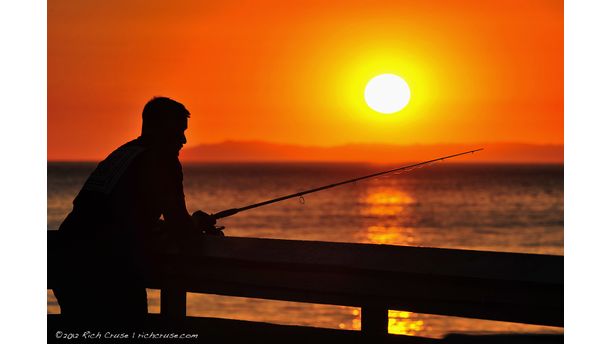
[210,148,484,220]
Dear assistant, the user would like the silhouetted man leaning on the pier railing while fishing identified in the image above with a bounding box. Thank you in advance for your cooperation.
[54,97,215,319]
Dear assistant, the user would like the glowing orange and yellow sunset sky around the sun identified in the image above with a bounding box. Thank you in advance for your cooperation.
[48,0,563,160]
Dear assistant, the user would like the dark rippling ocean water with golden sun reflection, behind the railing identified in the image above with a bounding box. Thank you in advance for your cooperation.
[47,162,563,337]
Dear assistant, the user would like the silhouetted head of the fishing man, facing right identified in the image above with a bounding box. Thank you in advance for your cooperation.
[142,97,189,149]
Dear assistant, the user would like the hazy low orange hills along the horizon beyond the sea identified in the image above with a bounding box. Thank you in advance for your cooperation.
[181,141,563,163]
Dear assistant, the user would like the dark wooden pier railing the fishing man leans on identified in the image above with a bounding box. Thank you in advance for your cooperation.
[48,231,563,334]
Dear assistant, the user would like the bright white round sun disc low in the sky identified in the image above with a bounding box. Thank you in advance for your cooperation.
[364,74,410,114]
